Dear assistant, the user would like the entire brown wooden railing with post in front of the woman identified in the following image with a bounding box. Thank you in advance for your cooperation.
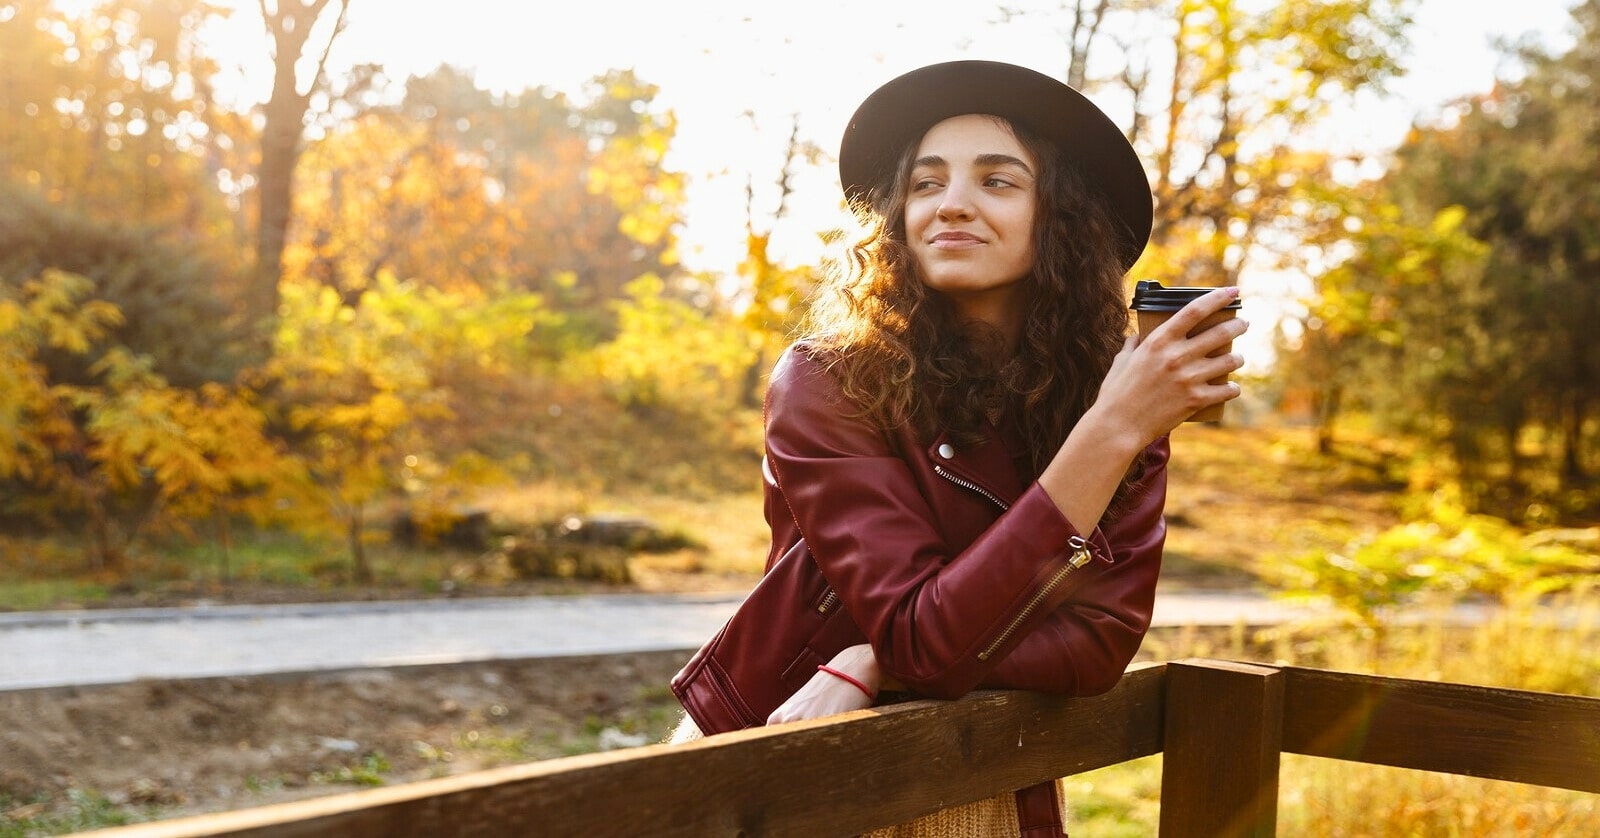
[81,660,1600,838]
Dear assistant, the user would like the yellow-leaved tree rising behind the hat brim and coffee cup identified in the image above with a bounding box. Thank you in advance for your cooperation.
[1011,0,1414,285]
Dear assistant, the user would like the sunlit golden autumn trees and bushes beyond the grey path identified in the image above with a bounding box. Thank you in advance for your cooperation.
[0,0,1600,608]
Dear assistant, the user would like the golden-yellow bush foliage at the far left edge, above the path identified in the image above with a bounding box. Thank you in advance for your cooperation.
[0,272,298,569]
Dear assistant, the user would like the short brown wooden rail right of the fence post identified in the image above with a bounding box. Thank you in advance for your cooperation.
[1283,667,1600,793]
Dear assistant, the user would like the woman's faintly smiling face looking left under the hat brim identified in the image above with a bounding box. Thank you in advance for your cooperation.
[906,114,1038,328]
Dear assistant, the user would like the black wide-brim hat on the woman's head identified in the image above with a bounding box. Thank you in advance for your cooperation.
[838,61,1152,269]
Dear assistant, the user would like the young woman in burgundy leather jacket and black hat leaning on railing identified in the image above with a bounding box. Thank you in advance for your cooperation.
[674,61,1246,836]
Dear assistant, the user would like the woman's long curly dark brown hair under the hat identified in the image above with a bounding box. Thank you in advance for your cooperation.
[805,117,1138,496]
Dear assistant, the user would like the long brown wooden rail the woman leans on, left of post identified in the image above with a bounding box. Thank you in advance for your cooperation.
[78,667,1163,838]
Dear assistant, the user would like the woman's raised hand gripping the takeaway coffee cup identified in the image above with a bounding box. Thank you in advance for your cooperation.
[1093,288,1250,448]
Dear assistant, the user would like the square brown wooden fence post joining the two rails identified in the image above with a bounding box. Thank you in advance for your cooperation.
[1162,660,1285,838]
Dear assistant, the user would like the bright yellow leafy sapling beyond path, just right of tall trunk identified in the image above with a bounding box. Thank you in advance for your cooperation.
[253,272,560,582]
